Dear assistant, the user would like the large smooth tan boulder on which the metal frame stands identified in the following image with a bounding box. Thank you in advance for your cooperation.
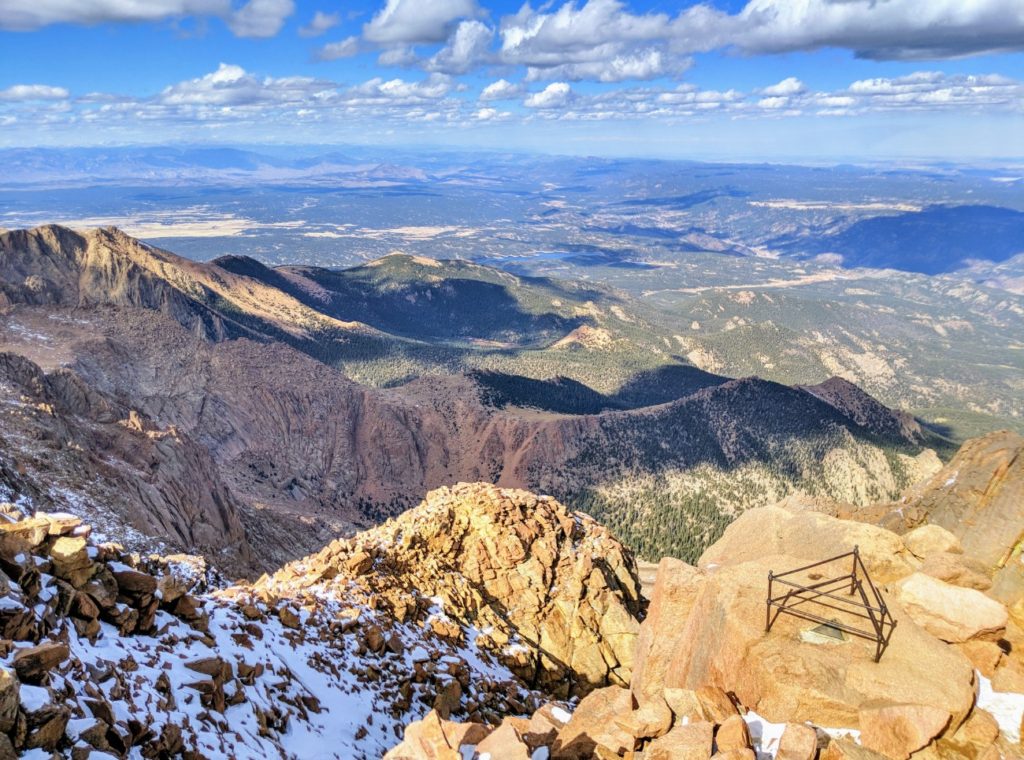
[631,508,974,728]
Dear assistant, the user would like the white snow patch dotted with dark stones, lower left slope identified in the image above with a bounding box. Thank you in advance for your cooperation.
[5,581,544,760]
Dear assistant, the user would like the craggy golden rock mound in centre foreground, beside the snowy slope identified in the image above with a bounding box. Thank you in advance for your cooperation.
[257,483,641,698]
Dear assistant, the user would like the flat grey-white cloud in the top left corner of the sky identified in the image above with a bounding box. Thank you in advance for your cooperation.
[0,0,295,37]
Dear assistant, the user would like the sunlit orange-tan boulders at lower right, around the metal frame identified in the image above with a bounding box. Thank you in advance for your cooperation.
[387,499,1024,760]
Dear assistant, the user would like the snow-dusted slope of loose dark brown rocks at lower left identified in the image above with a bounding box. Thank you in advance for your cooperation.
[0,503,577,760]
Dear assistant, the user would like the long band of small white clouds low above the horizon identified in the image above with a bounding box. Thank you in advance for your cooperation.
[0,64,1024,143]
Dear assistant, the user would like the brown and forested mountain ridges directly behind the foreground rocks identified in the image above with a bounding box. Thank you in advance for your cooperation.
[0,226,948,573]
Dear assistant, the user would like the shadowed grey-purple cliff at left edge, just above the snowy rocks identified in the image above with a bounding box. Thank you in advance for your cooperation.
[0,353,253,574]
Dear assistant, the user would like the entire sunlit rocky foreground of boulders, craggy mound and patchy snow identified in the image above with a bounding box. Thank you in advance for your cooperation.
[0,432,1024,760]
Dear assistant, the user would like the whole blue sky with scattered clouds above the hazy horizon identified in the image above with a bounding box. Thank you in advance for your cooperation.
[0,0,1024,162]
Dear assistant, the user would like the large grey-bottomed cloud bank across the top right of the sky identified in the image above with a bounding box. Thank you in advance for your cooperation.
[299,0,1024,82]
